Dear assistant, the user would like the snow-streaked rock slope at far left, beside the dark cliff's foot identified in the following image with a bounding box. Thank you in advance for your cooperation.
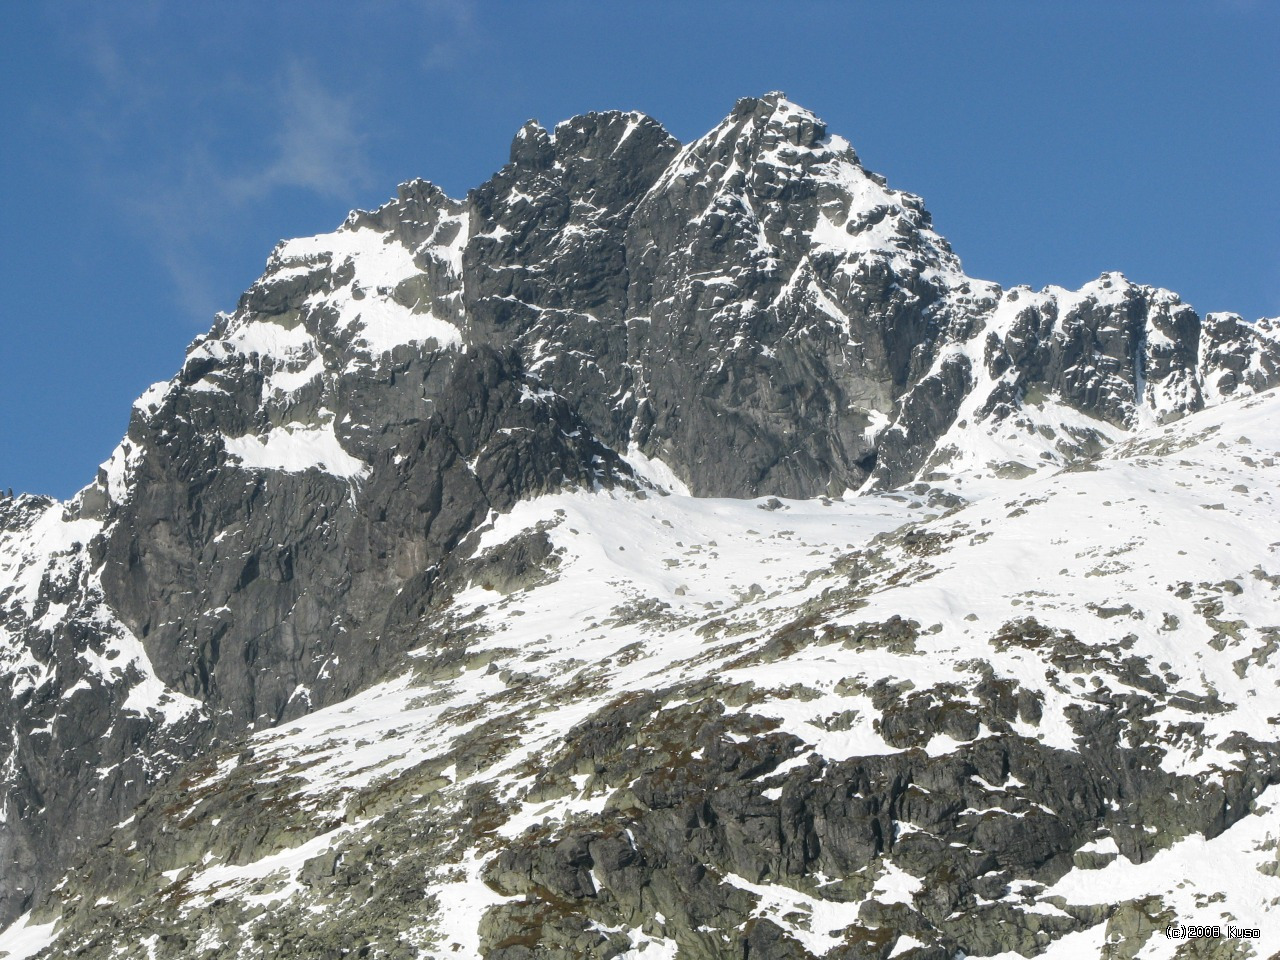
[0,497,206,923]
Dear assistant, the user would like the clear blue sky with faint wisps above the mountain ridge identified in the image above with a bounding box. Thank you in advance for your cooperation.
[0,0,1280,497]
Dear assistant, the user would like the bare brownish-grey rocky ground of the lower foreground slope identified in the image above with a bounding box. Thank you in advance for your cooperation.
[27,530,1280,960]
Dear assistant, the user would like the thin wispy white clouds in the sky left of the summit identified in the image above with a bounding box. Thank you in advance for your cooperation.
[58,8,465,324]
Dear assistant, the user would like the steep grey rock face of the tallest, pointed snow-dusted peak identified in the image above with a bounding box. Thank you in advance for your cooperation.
[614,95,959,495]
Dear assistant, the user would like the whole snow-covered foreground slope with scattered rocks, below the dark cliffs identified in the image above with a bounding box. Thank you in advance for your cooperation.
[10,393,1280,957]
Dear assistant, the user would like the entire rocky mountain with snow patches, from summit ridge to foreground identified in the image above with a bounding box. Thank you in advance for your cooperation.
[0,93,1280,960]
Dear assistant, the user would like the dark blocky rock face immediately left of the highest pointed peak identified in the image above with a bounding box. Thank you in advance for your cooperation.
[462,113,680,463]
